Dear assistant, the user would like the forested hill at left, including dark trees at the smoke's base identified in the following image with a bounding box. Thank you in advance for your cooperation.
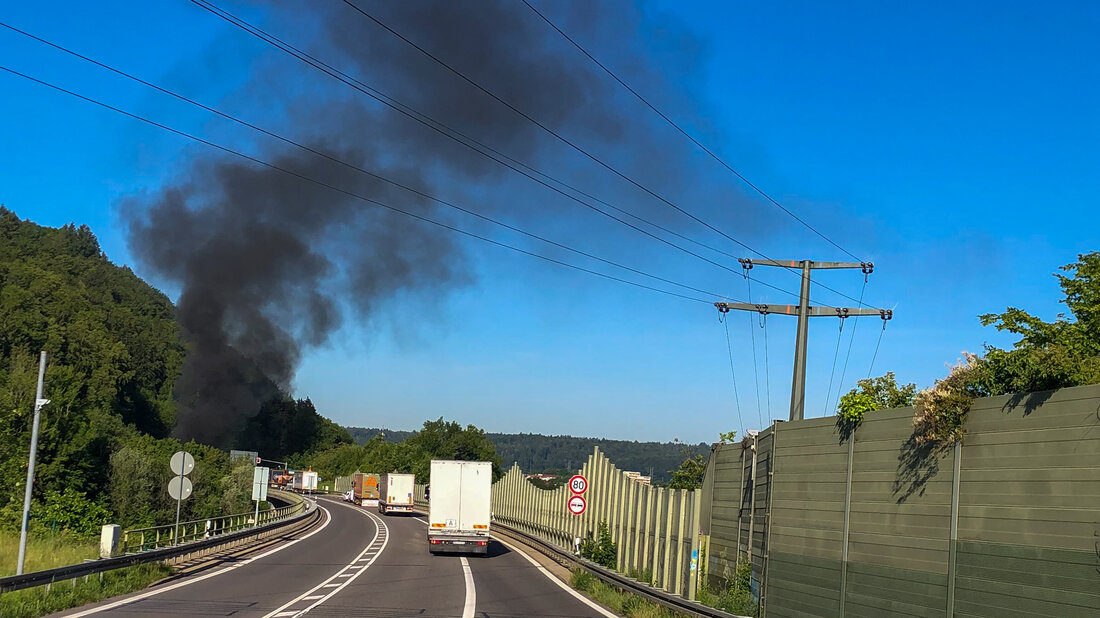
[0,207,350,534]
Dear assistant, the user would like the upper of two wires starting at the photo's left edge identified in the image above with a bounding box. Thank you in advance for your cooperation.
[0,22,739,298]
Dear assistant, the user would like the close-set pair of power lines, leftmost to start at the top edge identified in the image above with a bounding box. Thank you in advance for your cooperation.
[184,0,818,297]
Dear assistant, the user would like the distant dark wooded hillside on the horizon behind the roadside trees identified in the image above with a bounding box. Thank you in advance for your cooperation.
[348,427,711,483]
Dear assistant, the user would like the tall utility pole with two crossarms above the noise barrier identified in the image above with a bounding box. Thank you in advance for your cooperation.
[714,257,893,420]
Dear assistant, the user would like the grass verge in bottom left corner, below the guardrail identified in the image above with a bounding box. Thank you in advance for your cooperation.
[0,563,173,618]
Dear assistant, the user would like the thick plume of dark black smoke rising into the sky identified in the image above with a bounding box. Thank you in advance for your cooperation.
[123,0,708,445]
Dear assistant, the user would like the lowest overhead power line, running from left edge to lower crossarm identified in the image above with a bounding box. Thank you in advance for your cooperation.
[0,65,711,304]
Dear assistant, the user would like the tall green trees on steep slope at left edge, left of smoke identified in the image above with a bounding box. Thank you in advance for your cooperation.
[0,207,184,527]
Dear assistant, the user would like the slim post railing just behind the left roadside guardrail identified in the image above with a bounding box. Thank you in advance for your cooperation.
[119,490,306,553]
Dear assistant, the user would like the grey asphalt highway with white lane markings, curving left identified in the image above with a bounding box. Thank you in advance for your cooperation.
[59,498,615,618]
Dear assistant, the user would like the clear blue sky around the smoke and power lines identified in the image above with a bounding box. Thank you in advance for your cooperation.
[0,0,1100,441]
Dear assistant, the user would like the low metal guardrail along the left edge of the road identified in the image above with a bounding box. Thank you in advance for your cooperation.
[0,490,320,594]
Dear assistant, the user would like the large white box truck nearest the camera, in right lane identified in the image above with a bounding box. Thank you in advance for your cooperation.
[428,460,493,554]
